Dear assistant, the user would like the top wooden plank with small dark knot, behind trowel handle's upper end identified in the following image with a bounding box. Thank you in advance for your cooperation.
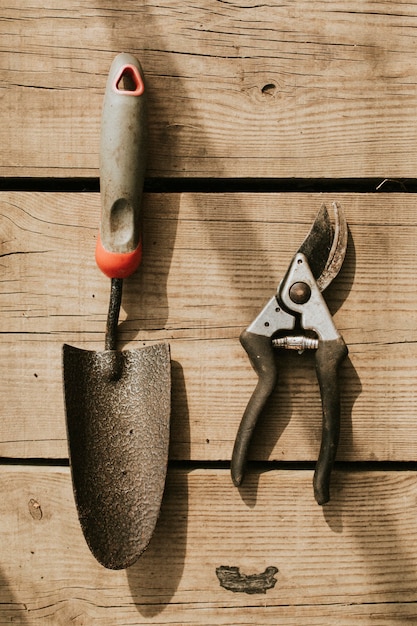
[0,0,417,177]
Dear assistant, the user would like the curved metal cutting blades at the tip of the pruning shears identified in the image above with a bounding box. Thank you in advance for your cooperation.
[298,202,348,291]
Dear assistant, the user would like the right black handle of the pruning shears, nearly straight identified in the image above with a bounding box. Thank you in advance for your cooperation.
[313,337,348,504]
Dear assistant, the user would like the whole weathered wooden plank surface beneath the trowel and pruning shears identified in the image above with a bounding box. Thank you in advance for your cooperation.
[0,0,417,626]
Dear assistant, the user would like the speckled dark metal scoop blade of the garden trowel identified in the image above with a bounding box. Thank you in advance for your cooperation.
[63,344,171,569]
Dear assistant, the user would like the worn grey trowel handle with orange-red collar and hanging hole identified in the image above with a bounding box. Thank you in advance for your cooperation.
[96,53,147,278]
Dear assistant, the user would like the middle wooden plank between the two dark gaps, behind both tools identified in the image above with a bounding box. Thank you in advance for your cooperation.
[0,193,417,461]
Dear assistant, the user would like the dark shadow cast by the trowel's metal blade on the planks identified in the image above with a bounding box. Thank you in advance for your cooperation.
[126,361,190,619]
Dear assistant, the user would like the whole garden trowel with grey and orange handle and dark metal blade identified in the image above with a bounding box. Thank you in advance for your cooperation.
[63,54,171,569]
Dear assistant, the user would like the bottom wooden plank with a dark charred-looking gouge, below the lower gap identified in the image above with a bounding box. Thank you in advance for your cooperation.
[0,466,417,626]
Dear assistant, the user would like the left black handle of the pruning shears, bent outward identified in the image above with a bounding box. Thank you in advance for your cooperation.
[231,330,278,487]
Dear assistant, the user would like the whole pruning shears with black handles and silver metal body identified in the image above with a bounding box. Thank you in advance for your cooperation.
[231,203,348,505]
